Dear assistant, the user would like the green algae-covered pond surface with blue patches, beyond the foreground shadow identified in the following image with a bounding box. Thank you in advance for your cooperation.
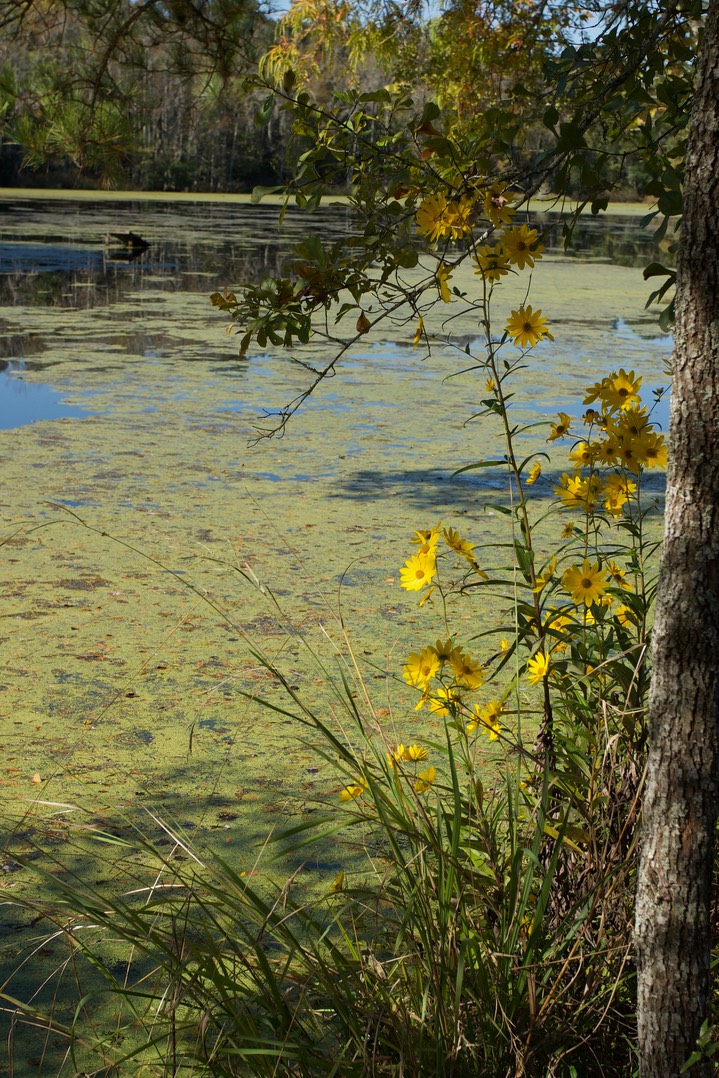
[0,193,670,866]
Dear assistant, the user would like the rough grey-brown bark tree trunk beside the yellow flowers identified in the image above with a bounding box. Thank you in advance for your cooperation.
[636,0,719,1078]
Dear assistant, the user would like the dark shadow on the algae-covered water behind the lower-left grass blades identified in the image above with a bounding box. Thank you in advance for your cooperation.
[0,750,349,1076]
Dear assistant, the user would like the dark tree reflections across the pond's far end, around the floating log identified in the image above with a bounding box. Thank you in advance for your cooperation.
[0,199,653,314]
